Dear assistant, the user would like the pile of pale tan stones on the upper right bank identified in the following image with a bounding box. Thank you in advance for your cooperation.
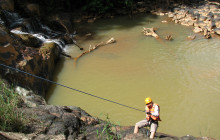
[168,3,220,39]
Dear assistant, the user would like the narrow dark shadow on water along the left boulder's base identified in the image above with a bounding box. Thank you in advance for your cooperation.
[45,57,65,102]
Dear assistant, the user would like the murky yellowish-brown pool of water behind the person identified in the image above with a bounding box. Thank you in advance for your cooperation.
[47,15,220,139]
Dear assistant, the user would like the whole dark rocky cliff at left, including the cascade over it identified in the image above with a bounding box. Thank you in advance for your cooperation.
[0,0,72,97]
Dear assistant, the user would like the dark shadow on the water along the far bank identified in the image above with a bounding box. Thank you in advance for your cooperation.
[75,13,158,42]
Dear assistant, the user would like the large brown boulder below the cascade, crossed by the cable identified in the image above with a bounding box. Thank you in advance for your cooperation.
[0,30,61,97]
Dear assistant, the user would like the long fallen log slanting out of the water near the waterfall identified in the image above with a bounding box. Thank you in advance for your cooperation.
[74,37,116,61]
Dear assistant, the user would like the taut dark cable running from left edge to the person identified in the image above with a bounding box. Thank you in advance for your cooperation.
[0,63,145,112]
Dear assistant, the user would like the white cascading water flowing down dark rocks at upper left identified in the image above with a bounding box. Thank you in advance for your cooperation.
[0,11,74,52]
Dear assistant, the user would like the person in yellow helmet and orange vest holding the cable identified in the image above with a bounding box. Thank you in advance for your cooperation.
[134,97,161,139]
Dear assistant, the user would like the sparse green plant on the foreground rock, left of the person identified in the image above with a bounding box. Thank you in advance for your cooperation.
[96,114,121,140]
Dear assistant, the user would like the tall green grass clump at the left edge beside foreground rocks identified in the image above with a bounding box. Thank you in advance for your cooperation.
[0,79,27,132]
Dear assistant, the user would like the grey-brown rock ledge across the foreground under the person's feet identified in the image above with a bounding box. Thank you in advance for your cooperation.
[0,87,215,140]
